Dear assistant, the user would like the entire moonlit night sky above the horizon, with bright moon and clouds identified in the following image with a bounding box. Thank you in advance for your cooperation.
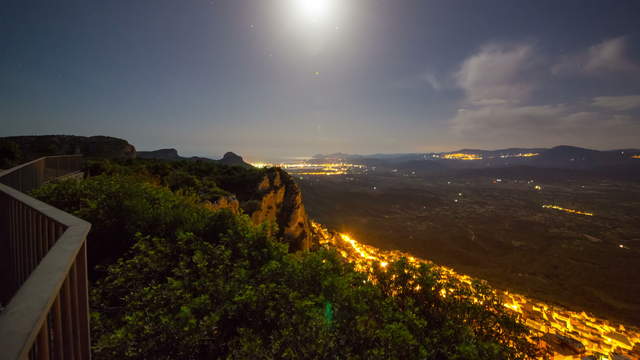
[0,0,640,160]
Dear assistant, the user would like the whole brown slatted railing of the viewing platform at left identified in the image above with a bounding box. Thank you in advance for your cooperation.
[0,156,91,359]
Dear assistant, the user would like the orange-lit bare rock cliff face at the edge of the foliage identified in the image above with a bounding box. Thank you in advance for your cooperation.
[250,168,314,251]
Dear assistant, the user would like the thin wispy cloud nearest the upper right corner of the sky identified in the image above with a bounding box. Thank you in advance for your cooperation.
[551,37,640,75]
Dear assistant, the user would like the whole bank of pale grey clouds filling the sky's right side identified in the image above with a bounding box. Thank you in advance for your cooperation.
[450,38,640,148]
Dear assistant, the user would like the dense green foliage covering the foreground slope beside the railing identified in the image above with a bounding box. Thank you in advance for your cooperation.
[36,163,533,359]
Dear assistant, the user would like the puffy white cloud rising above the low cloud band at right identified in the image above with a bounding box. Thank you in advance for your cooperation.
[454,44,539,105]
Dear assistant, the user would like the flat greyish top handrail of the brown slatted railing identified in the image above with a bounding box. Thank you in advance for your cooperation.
[0,155,91,359]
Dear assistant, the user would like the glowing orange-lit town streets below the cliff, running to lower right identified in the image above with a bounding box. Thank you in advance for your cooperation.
[313,223,640,359]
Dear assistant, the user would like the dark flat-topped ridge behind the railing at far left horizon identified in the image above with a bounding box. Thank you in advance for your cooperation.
[1,135,136,161]
